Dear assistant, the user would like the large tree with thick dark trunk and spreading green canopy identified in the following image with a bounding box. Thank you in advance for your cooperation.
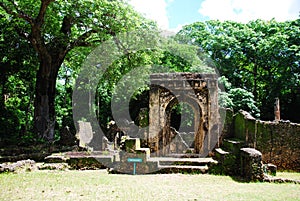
[0,0,142,141]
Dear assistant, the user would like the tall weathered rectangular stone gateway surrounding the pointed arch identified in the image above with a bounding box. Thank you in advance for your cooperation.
[147,73,220,157]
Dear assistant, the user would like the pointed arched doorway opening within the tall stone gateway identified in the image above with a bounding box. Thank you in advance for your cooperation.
[159,97,203,155]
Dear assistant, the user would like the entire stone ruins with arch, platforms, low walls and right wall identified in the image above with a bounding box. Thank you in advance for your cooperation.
[0,73,300,183]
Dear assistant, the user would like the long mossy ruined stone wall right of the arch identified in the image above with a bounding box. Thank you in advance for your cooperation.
[233,111,300,172]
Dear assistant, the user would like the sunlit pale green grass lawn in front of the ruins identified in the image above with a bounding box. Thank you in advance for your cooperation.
[0,170,300,201]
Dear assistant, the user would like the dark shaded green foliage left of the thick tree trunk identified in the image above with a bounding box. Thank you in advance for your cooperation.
[0,14,38,144]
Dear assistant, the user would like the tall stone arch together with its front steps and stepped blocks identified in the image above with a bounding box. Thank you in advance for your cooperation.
[94,73,220,173]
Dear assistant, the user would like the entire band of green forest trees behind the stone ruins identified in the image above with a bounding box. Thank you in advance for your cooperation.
[0,0,300,146]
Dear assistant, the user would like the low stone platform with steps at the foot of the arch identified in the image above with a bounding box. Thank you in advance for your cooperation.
[45,152,217,174]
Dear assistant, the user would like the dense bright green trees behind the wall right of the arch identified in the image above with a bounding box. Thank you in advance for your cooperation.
[177,19,300,121]
